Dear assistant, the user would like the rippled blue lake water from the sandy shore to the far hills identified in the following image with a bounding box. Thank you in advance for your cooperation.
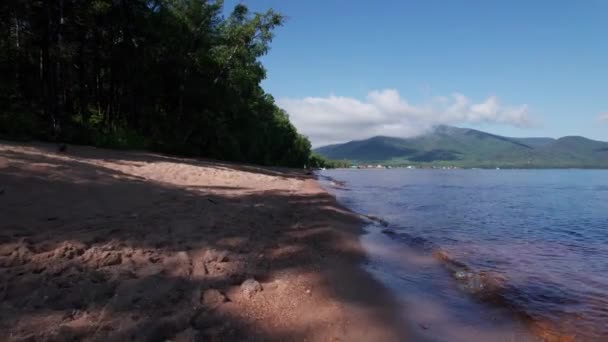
[320,169,608,341]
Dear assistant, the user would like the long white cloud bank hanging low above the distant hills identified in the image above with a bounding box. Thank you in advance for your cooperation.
[277,89,531,147]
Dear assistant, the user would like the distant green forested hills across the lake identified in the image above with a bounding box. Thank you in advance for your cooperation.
[315,125,608,168]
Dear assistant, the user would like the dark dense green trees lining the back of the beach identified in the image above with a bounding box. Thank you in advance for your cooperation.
[0,0,310,167]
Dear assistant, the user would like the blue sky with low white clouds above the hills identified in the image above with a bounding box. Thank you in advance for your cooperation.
[226,0,608,145]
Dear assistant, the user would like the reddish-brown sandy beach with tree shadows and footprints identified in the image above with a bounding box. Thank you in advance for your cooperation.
[0,141,408,341]
